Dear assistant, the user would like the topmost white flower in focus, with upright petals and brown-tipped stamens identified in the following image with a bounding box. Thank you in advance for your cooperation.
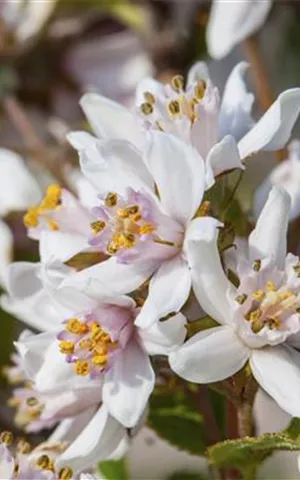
[77,62,300,188]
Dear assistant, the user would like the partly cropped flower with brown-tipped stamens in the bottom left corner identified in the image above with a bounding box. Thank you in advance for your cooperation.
[0,432,93,480]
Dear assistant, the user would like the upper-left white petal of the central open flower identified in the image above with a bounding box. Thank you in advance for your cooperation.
[68,132,153,195]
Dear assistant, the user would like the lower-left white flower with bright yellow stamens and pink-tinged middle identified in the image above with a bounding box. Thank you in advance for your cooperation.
[17,284,186,471]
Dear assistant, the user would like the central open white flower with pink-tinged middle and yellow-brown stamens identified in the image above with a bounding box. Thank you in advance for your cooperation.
[64,132,219,327]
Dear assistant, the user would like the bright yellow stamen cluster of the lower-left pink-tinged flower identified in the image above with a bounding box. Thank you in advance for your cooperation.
[58,316,119,378]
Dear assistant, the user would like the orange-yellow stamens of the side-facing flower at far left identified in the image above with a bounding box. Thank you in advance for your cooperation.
[23,184,62,230]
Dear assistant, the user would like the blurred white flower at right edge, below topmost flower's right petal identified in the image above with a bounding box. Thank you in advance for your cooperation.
[253,140,300,220]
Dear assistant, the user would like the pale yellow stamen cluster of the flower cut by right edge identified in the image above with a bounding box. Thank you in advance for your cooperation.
[236,281,300,333]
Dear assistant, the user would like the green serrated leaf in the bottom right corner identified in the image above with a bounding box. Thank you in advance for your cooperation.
[208,418,300,478]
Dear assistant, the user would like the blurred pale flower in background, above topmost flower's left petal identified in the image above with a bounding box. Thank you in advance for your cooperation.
[64,30,153,105]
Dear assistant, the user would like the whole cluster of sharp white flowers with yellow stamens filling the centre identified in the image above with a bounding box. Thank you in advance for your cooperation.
[0,57,300,480]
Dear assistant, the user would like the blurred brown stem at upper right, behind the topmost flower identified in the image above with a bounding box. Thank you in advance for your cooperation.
[243,35,273,111]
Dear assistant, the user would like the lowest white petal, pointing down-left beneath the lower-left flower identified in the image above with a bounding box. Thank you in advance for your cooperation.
[55,405,127,472]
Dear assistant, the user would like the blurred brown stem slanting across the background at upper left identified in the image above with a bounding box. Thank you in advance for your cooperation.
[3,96,70,190]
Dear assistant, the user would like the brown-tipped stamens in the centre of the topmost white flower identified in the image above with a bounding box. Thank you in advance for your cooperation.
[140,75,206,131]
